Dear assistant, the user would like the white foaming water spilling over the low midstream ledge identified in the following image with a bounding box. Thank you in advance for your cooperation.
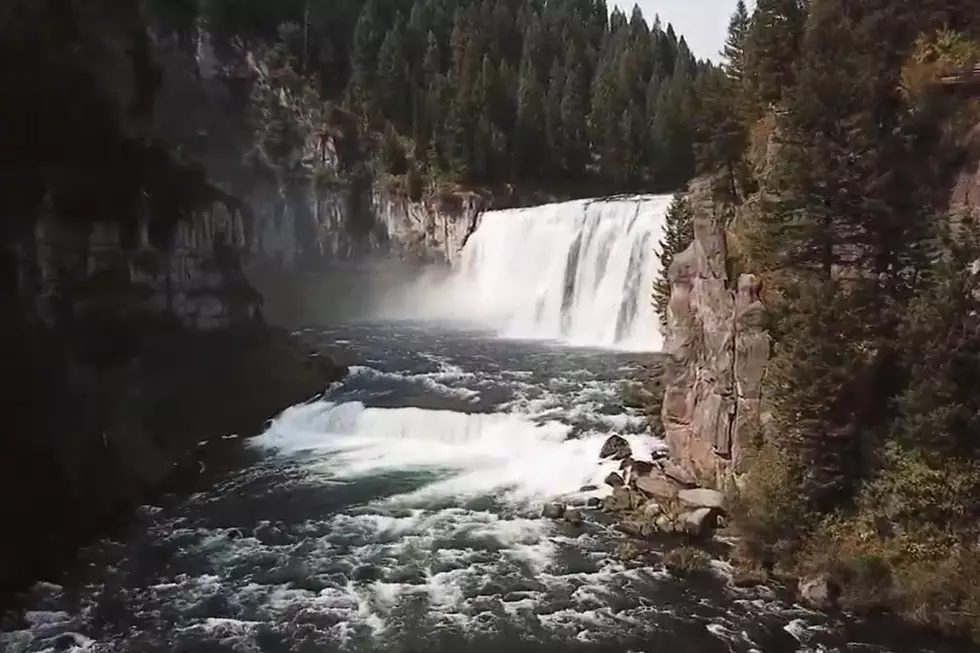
[252,402,657,504]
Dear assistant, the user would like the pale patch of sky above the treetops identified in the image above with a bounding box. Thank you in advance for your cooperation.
[610,0,755,62]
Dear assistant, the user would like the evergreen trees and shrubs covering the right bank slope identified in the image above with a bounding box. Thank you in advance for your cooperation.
[728,0,980,636]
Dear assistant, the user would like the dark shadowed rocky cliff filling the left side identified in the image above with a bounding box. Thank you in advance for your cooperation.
[0,0,343,609]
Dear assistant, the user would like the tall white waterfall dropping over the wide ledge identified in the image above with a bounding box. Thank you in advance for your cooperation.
[440,195,671,350]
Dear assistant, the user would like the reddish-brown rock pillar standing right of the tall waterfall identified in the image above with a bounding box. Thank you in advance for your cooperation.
[661,180,770,488]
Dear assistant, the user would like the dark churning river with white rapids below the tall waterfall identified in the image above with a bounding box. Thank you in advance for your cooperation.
[0,322,962,653]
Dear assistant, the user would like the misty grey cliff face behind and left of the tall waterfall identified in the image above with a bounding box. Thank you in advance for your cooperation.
[154,31,485,270]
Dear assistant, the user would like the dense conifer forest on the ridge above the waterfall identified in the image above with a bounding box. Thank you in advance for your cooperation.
[148,0,734,193]
